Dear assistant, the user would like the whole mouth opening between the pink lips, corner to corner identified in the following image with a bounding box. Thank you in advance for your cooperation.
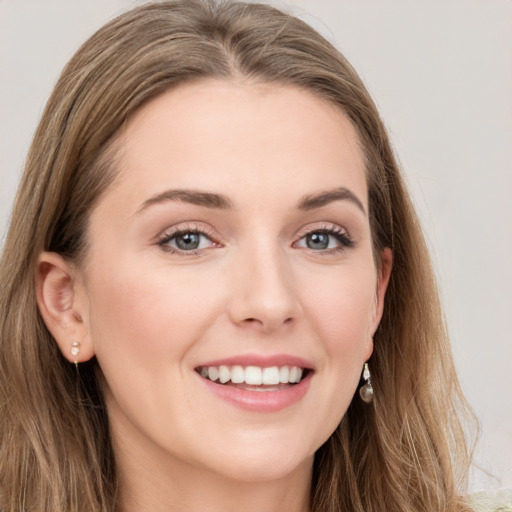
[196,365,309,391]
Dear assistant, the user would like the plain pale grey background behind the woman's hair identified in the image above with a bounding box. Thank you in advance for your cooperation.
[0,0,512,490]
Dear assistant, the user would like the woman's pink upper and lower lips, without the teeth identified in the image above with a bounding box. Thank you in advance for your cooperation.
[197,355,314,413]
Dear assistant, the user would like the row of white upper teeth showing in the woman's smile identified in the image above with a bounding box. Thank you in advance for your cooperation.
[199,365,303,386]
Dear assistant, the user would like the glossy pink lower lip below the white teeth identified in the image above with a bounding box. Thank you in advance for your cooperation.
[198,372,313,413]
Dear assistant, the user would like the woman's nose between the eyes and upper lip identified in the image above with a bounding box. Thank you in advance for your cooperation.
[229,243,302,332]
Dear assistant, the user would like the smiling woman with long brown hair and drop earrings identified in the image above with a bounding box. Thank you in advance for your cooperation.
[0,1,484,512]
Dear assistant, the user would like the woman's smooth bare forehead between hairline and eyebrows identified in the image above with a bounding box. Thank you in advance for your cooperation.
[100,80,367,214]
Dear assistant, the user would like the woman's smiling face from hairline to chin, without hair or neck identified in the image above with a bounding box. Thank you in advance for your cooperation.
[77,80,389,481]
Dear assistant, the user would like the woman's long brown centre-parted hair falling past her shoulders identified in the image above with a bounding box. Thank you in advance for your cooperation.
[0,0,471,512]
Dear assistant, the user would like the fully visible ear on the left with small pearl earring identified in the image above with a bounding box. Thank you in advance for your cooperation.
[36,252,94,362]
